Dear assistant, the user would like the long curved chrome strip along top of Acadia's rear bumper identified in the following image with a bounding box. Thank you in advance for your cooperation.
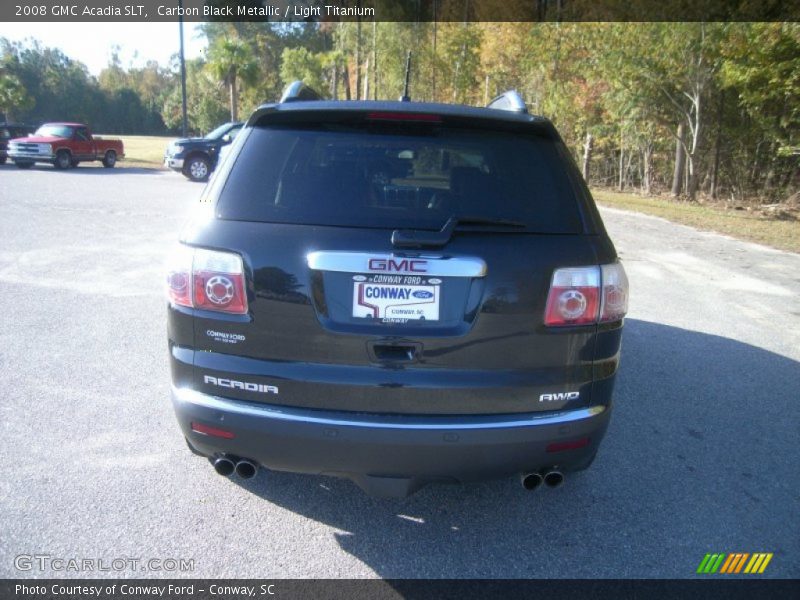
[172,387,606,431]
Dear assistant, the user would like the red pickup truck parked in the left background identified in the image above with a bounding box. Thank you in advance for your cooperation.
[8,123,125,169]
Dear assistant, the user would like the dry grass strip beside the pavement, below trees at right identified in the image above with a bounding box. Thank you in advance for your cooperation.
[592,190,800,252]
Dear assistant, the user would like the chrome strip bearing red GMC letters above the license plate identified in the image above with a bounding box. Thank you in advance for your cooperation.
[306,251,486,277]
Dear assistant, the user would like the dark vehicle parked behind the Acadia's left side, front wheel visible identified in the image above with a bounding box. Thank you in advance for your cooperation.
[164,121,244,181]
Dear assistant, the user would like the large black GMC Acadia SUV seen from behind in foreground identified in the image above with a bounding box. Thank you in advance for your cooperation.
[167,84,628,496]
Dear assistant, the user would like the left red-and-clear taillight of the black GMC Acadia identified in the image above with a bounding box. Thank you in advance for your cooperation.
[167,245,247,315]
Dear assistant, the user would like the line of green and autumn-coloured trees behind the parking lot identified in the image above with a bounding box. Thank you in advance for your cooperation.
[0,21,800,201]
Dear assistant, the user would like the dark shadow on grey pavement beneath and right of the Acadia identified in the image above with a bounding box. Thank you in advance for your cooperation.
[228,320,800,578]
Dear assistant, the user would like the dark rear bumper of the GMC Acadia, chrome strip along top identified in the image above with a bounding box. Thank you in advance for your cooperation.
[172,388,611,495]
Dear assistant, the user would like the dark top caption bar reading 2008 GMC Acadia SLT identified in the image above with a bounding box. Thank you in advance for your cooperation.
[0,0,800,23]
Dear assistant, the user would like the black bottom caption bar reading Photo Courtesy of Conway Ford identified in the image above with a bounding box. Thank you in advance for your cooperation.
[0,576,800,600]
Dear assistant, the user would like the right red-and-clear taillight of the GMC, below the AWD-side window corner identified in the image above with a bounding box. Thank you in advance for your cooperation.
[544,263,628,327]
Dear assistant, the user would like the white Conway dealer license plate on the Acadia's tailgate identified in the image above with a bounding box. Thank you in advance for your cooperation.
[353,276,441,323]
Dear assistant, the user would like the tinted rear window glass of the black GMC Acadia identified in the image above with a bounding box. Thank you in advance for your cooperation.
[216,124,582,233]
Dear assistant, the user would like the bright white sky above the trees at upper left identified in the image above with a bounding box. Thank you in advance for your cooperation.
[0,23,206,75]
